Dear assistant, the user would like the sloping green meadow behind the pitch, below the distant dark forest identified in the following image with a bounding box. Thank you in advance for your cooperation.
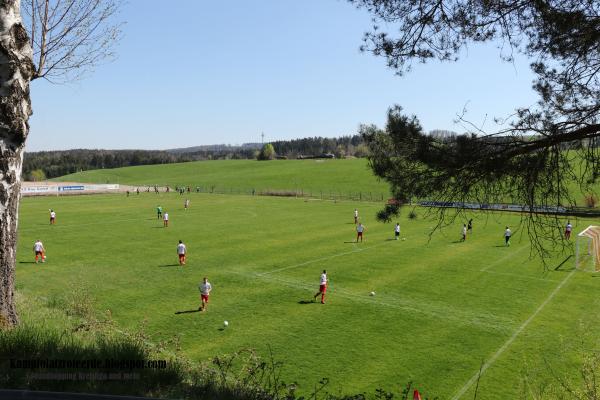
[56,159,389,197]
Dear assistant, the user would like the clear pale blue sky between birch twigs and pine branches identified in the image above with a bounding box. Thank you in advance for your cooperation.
[27,0,536,151]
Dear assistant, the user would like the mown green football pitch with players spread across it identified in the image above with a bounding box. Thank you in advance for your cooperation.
[16,192,600,399]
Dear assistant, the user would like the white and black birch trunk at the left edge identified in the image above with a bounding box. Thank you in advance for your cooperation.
[0,0,34,327]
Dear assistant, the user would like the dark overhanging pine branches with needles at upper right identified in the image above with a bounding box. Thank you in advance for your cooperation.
[349,0,600,256]
